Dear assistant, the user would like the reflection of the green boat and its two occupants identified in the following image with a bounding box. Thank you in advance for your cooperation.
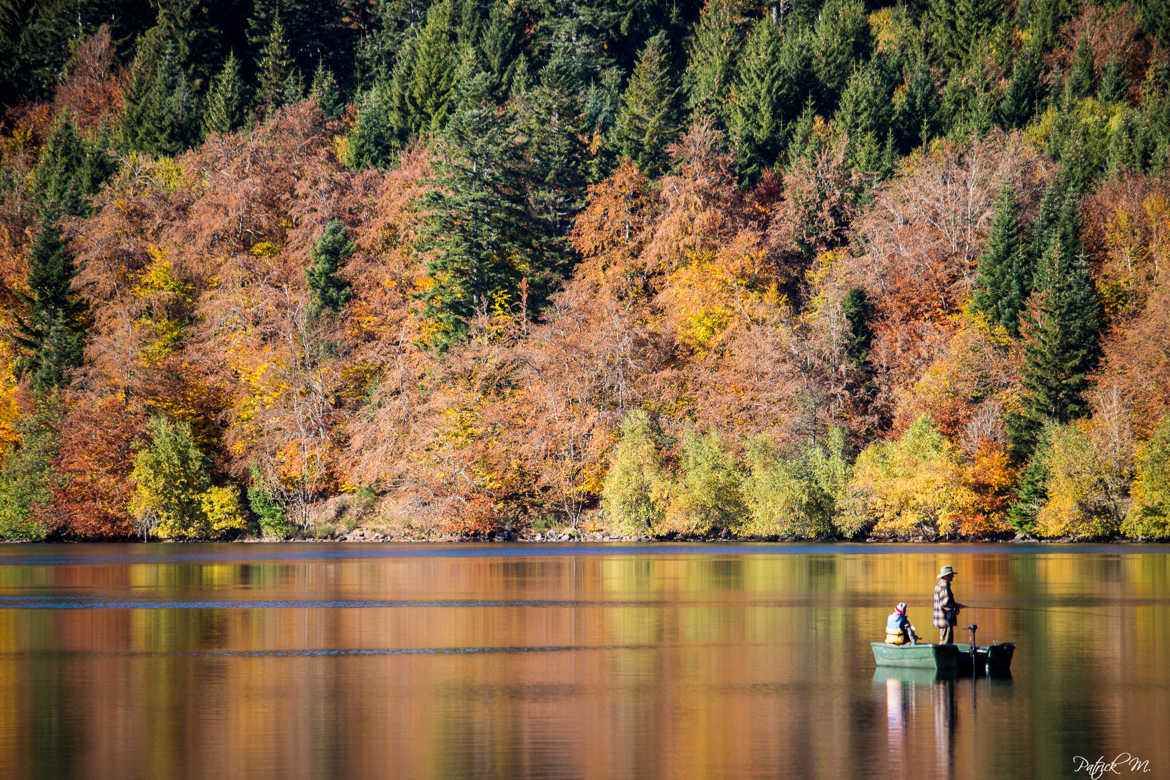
[874,667,1012,778]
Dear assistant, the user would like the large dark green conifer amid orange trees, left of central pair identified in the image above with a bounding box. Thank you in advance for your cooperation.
[418,69,534,351]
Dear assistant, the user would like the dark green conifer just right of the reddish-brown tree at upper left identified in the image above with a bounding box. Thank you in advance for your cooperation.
[121,27,199,154]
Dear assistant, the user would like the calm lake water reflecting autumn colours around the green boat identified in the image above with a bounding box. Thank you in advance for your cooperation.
[0,544,1170,778]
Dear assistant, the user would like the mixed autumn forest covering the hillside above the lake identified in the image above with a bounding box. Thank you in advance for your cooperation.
[0,0,1170,540]
